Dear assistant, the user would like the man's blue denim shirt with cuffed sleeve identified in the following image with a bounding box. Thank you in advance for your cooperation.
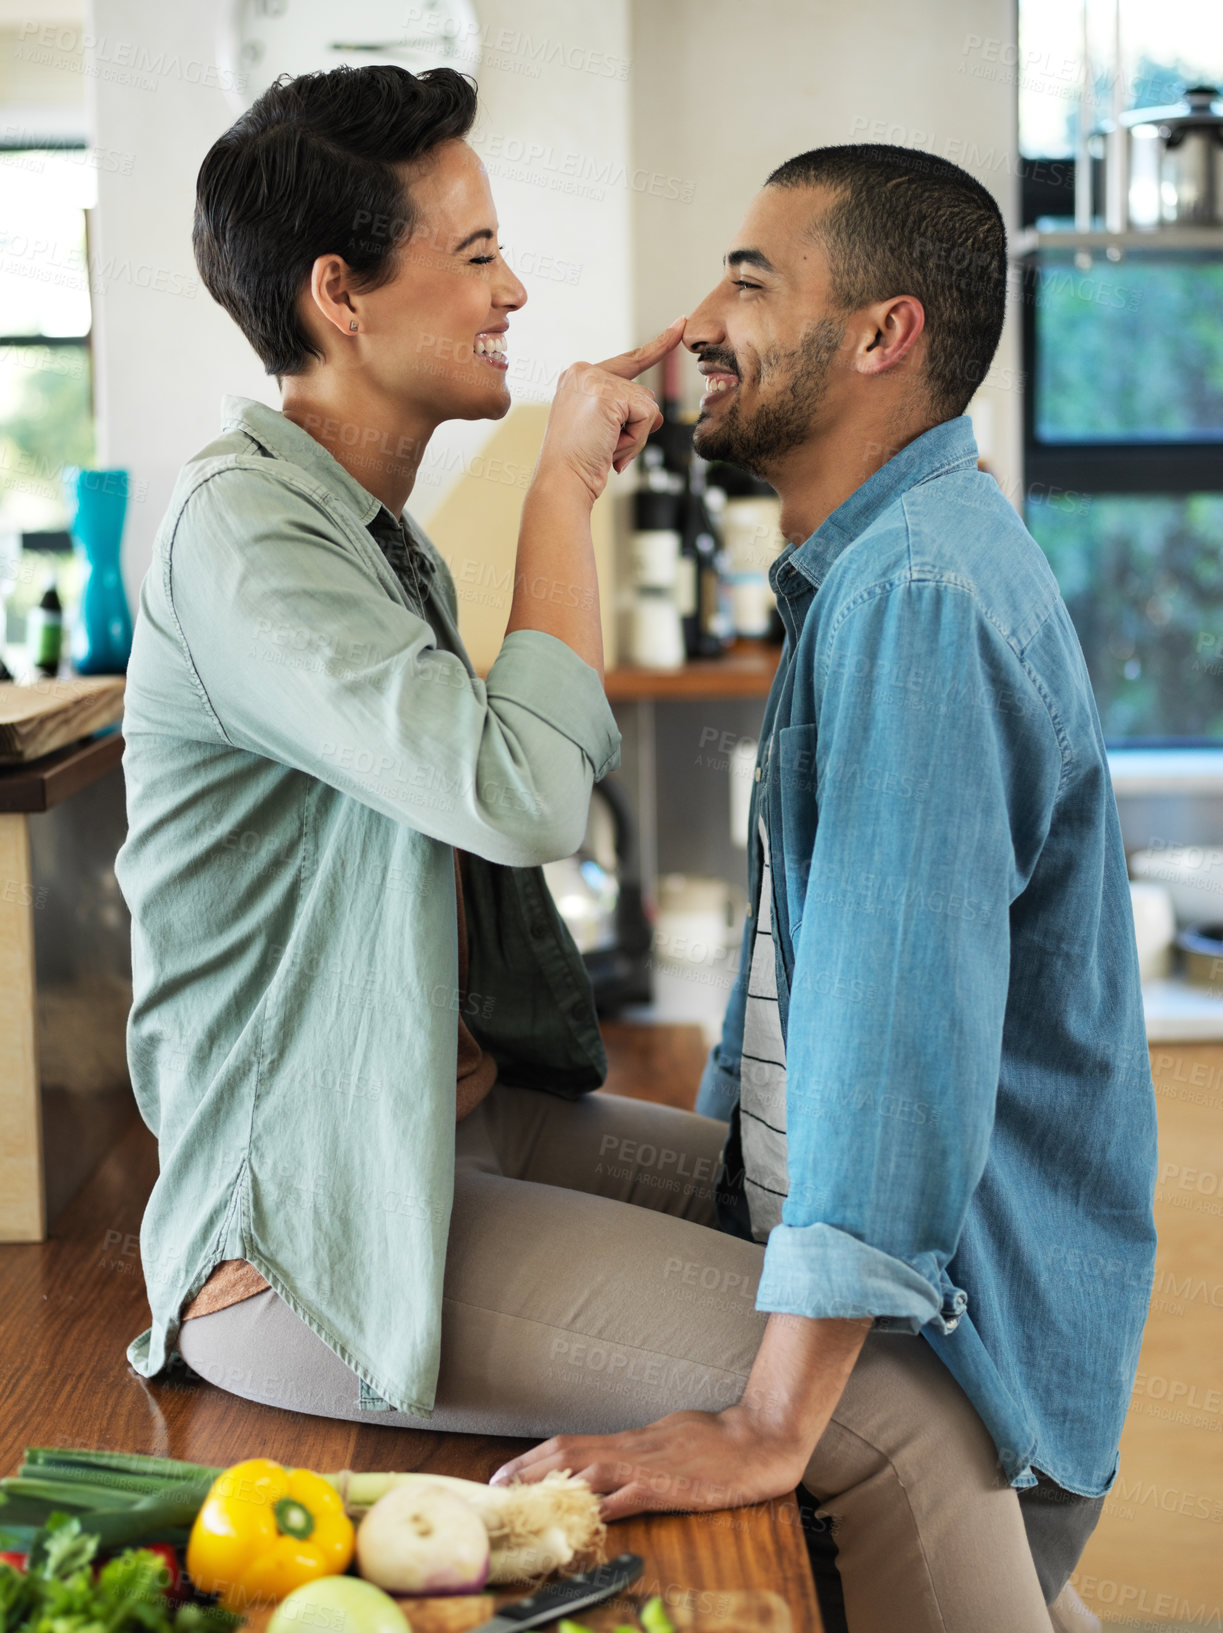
[697,416,1156,1496]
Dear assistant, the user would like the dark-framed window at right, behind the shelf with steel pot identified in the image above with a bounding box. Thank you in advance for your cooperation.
[1017,0,1223,746]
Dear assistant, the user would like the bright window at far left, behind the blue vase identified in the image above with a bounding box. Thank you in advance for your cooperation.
[0,144,96,645]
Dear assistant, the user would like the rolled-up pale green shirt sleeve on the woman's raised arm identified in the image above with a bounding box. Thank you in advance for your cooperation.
[163,465,619,865]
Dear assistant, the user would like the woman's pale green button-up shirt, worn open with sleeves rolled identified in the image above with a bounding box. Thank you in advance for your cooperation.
[116,397,619,1414]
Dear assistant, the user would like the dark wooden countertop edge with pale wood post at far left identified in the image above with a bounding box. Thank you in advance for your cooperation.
[0,732,122,1243]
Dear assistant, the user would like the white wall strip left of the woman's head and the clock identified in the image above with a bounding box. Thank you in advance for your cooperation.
[87,0,278,604]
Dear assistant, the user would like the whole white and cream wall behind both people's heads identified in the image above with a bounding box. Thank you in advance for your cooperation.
[81,0,1019,591]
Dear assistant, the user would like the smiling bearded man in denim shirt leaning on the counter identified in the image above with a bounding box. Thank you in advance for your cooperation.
[501,145,1156,1633]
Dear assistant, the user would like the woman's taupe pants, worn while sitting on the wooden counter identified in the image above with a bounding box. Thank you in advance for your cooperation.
[178,1086,1102,1633]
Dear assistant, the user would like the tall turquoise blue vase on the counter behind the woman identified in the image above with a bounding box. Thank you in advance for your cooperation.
[64,465,132,674]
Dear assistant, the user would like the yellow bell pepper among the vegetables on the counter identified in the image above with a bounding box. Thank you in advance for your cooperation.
[186,1457,354,1612]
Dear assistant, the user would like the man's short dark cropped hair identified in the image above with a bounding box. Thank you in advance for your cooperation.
[764,144,1006,420]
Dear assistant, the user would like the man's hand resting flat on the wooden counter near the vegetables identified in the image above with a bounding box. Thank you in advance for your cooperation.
[491,1404,813,1520]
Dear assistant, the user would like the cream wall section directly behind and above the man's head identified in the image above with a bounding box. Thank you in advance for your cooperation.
[632,0,1022,498]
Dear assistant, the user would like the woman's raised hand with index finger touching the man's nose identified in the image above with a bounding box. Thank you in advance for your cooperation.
[537,317,686,503]
